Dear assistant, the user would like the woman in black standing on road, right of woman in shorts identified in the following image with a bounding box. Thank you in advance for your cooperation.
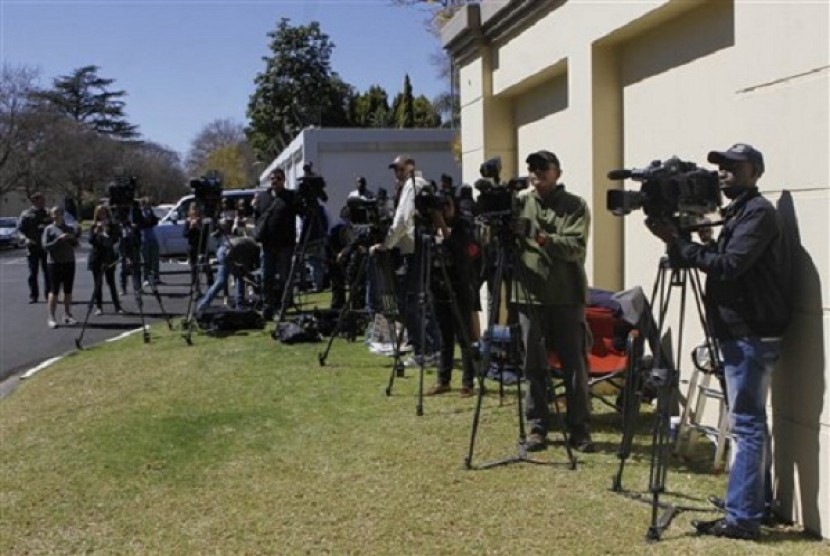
[87,205,124,315]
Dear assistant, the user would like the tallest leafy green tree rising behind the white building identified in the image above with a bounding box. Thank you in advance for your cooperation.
[246,18,351,160]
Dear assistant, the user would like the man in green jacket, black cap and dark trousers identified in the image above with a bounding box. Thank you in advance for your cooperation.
[511,151,593,452]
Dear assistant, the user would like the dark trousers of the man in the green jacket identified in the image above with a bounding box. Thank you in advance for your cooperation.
[517,305,591,440]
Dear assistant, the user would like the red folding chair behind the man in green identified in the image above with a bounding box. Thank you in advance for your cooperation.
[548,306,643,411]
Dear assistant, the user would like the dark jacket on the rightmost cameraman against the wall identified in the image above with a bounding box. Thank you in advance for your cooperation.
[669,189,794,340]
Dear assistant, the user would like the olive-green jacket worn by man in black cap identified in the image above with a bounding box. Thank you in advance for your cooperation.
[510,184,591,305]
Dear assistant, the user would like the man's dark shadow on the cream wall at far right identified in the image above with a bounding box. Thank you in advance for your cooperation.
[772,191,829,536]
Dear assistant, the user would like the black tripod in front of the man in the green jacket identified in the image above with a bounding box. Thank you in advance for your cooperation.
[464,222,576,469]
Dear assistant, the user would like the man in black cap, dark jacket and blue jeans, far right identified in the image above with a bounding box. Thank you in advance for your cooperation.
[646,143,792,539]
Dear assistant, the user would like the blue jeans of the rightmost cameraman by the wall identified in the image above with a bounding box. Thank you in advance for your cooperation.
[720,337,781,531]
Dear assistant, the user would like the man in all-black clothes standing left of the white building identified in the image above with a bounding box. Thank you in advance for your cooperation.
[254,167,302,319]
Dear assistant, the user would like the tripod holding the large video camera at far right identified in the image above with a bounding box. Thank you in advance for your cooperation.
[611,256,719,541]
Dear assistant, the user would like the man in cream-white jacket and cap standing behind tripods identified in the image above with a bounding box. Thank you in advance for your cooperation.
[370,155,438,366]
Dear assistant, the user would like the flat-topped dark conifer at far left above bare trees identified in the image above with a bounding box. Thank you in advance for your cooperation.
[31,65,139,139]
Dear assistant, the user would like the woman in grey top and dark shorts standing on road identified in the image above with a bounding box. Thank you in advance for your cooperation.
[42,207,78,328]
